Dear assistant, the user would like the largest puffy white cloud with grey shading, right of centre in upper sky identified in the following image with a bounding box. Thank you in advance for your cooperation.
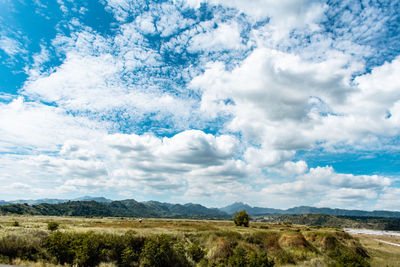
[191,49,354,154]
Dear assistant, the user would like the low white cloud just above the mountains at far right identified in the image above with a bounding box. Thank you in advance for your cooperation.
[262,166,391,209]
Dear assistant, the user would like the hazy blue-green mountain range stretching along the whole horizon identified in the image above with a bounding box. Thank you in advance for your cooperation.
[0,196,400,219]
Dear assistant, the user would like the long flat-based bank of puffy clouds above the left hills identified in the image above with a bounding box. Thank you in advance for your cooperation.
[0,130,250,201]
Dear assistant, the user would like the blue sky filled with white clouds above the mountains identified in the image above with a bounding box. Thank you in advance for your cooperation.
[0,0,400,211]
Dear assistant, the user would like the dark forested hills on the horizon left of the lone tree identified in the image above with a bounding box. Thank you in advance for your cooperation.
[0,199,231,219]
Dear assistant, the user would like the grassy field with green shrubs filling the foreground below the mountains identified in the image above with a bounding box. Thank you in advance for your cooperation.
[0,216,400,266]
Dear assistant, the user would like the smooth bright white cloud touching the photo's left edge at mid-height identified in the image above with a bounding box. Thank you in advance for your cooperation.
[0,97,108,152]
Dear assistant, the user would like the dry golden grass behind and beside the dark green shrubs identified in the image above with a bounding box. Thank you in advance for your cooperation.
[0,216,392,267]
